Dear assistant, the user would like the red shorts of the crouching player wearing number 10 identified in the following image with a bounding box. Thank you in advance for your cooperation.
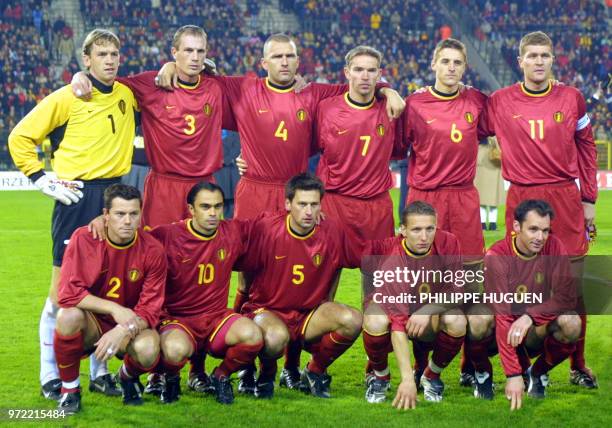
[159,309,242,358]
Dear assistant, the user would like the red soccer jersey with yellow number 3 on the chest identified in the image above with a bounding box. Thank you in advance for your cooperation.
[118,71,231,177]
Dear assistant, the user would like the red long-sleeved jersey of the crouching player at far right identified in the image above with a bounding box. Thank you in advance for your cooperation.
[484,235,576,376]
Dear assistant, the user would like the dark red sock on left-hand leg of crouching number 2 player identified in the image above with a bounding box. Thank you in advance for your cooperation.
[53,330,85,393]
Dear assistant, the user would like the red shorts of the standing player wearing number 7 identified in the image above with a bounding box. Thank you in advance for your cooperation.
[321,192,395,245]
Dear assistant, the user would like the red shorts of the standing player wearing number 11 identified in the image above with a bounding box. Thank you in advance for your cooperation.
[506,181,589,257]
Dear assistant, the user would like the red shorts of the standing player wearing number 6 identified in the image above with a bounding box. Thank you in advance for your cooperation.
[406,184,485,264]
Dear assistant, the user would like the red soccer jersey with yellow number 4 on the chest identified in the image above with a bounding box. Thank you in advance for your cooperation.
[216,77,347,184]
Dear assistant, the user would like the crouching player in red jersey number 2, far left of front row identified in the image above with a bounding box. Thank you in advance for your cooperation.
[54,184,167,414]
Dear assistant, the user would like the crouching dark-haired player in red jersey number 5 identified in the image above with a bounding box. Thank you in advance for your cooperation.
[240,174,362,398]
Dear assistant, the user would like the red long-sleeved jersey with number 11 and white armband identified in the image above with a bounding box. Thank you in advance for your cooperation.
[486,83,597,202]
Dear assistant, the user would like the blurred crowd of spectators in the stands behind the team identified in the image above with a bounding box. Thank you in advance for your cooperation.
[0,0,612,168]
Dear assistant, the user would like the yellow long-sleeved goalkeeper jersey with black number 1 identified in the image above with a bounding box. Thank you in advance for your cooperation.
[8,78,138,180]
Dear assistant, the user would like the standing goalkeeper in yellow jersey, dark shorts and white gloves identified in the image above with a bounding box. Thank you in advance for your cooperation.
[8,29,137,399]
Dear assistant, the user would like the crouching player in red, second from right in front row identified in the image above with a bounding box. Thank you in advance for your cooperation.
[363,201,466,409]
